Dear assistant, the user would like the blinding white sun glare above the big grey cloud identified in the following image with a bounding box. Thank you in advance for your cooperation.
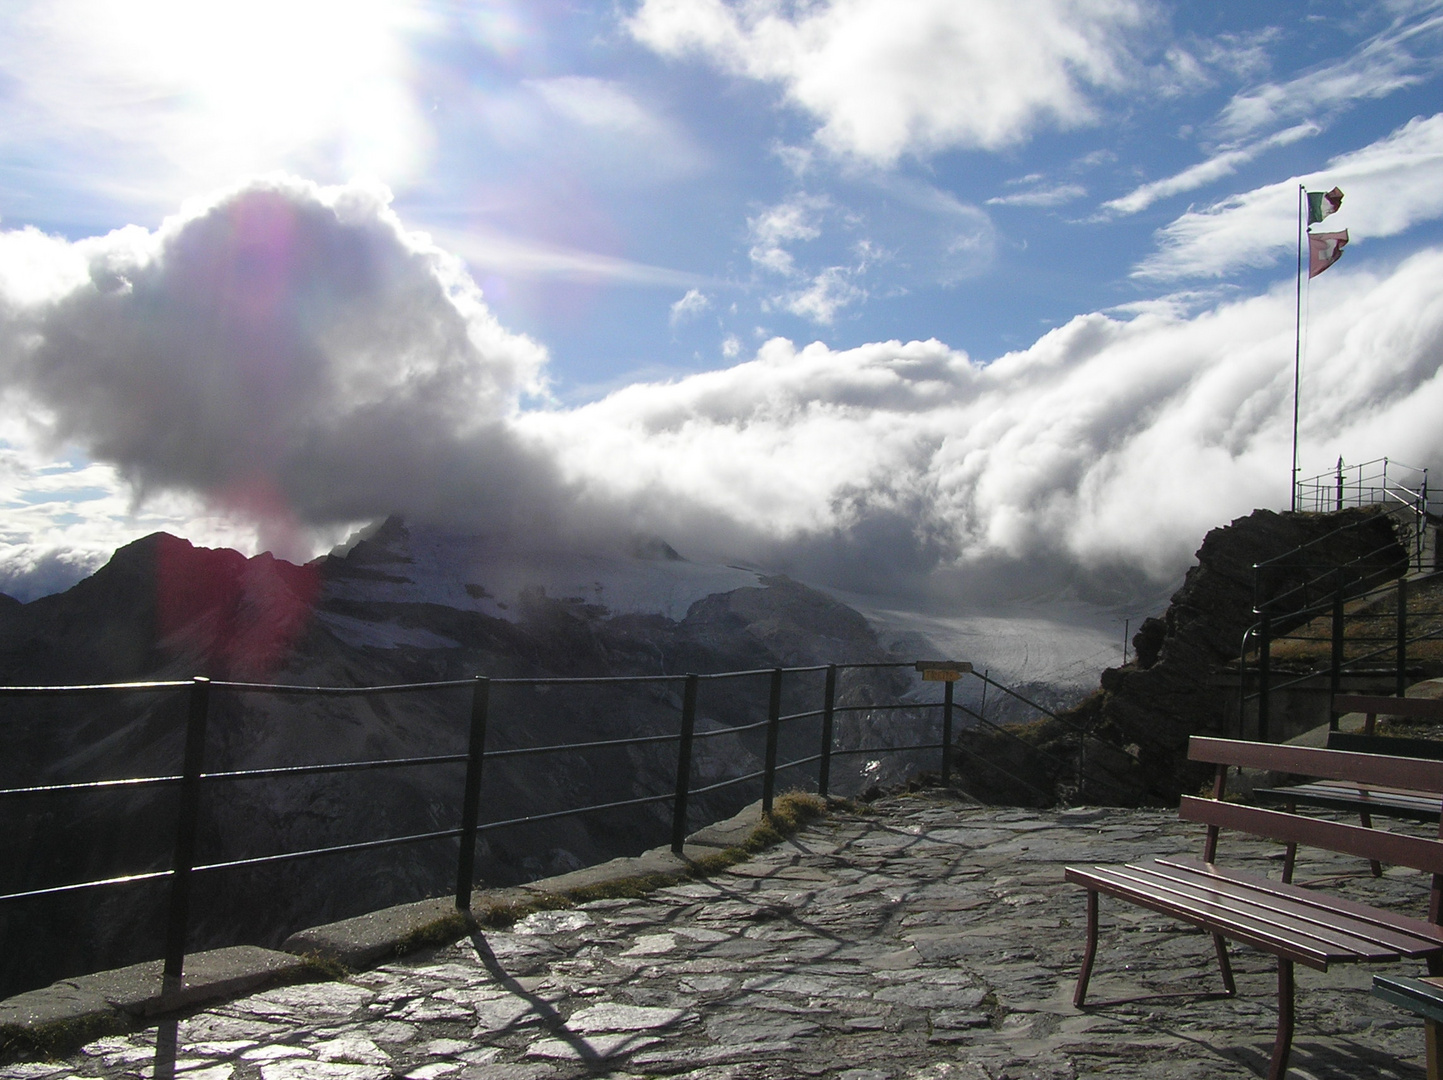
[36,0,427,183]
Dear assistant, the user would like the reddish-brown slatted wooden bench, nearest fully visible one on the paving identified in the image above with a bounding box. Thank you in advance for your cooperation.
[1066,736,1443,1080]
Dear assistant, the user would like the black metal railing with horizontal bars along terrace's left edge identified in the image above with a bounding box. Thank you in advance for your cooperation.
[0,652,1015,985]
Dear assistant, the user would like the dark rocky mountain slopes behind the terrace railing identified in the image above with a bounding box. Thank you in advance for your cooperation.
[0,518,937,995]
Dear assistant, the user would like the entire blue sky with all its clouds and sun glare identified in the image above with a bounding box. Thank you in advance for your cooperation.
[0,0,1443,620]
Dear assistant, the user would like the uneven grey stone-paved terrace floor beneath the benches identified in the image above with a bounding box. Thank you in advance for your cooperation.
[0,793,1426,1080]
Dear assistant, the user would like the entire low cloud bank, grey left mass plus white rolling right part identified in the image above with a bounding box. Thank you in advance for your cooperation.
[0,178,1443,615]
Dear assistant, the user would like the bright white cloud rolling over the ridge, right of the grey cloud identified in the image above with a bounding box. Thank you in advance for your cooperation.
[518,250,1443,595]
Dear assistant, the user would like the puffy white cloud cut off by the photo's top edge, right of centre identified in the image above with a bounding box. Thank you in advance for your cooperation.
[628,0,1152,165]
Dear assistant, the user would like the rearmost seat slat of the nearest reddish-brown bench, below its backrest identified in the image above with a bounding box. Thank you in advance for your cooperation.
[1149,859,1443,956]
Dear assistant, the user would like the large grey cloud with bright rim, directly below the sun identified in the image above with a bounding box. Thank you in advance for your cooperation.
[0,176,564,557]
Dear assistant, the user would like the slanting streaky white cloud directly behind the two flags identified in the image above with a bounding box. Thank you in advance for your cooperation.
[1134,113,1443,280]
